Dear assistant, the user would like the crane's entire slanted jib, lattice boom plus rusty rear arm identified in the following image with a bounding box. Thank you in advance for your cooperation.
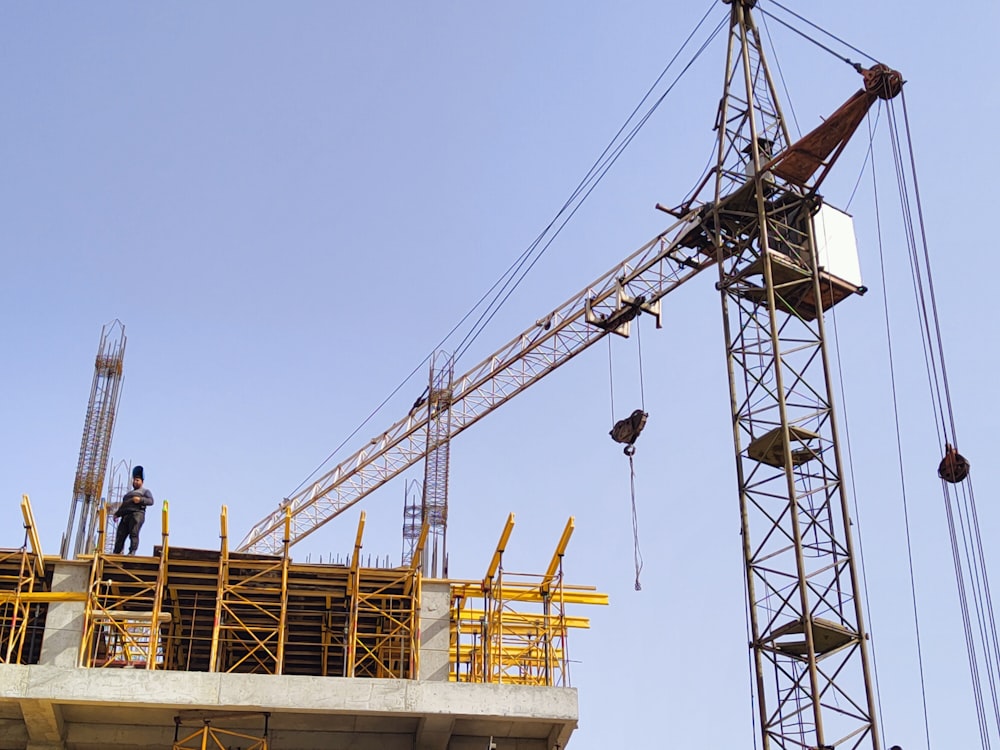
[238,66,902,553]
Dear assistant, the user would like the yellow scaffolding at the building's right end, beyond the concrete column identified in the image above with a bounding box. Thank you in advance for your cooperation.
[451,514,608,687]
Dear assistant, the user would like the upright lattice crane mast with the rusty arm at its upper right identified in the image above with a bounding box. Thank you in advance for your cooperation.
[709,0,901,750]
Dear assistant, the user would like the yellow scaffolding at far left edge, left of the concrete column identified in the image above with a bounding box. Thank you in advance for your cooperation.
[0,495,47,664]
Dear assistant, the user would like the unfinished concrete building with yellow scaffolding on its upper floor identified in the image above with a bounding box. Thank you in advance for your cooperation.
[0,497,607,750]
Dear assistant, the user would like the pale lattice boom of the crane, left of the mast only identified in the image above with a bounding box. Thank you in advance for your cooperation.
[239,210,714,553]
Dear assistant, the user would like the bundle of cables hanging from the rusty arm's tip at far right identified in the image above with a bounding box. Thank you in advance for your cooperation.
[889,89,1000,748]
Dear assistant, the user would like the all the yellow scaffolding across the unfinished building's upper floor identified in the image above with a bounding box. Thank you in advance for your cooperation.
[0,496,607,684]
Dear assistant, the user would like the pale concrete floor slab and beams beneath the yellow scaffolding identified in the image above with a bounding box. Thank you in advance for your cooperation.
[0,664,577,750]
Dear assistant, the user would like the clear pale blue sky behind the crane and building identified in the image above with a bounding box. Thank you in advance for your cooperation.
[0,0,1000,750]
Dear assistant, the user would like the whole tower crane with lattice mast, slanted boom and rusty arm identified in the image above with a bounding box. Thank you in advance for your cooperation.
[239,0,902,750]
